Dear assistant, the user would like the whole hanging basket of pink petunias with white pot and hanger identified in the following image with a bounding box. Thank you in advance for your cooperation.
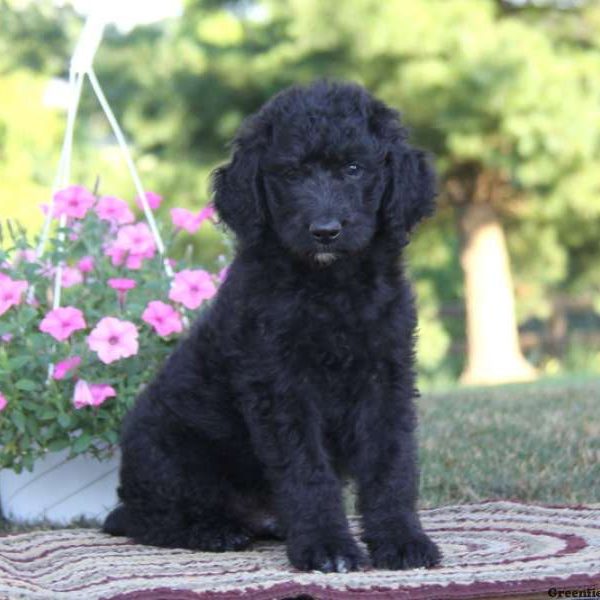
[0,14,225,522]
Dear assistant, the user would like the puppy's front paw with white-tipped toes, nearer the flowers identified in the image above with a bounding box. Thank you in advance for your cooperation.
[287,532,365,573]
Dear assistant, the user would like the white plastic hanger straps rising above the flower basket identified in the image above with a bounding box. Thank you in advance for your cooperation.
[36,12,173,282]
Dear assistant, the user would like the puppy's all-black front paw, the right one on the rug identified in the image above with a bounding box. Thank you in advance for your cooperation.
[369,532,442,570]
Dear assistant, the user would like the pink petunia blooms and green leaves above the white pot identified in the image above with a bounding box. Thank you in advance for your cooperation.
[0,186,220,478]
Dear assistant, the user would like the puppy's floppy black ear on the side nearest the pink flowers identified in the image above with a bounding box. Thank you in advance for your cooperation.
[211,120,266,243]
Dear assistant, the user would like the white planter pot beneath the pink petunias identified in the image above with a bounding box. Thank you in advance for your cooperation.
[0,450,119,525]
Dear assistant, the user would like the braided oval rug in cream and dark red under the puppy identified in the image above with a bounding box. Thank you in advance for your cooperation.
[0,502,600,600]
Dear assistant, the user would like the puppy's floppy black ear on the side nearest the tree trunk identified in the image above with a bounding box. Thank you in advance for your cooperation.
[370,100,436,238]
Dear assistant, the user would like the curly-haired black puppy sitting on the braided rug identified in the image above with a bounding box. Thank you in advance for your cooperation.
[104,82,440,571]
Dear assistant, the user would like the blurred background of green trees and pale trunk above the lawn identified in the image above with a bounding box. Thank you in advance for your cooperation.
[0,0,600,389]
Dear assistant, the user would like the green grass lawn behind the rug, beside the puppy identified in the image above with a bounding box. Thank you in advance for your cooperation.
[0,378,600,533]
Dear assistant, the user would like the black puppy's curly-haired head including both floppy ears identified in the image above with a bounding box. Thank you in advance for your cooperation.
[213,82,435,265]
